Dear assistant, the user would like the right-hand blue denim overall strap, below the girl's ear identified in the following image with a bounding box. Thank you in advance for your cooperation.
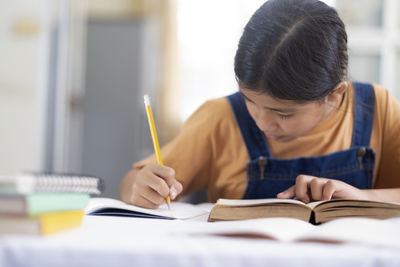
[351,83,375,147]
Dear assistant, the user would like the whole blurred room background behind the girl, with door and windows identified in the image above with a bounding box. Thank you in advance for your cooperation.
[0,0,400,198]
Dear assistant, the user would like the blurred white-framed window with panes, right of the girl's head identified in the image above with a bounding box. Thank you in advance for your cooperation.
[335,0,400,99]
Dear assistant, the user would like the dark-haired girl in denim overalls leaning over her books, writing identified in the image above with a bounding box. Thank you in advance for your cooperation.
[121,0,400,208]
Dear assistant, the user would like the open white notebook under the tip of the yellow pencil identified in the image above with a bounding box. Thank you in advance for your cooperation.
[85,198,209,220]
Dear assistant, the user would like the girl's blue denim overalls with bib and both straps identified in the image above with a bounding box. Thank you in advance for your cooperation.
[227,83,375,199]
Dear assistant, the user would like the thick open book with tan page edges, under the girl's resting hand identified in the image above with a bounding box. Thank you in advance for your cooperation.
[208,199,400,224]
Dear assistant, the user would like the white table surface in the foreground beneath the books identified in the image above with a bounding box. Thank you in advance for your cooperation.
[0,216,400,267]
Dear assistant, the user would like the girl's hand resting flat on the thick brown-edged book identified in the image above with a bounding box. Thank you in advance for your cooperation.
[277,174,368,203]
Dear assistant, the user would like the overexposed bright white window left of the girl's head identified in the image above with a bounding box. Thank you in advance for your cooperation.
[177,0,265,121]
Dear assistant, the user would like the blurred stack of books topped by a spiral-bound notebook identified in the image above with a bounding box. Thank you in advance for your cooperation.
[0,174,102,235]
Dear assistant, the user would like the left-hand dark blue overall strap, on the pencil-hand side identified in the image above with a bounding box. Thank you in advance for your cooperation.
[227,92,271,159]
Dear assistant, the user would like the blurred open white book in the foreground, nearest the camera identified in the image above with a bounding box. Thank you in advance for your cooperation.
[176,218,400,248]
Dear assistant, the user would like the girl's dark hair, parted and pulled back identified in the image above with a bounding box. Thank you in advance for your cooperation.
[235,0,348,101]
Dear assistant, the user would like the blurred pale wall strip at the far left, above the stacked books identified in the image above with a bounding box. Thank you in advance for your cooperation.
[0,0,41,174]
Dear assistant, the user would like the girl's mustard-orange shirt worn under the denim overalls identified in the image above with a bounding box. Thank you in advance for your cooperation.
[134,85,400,202]
